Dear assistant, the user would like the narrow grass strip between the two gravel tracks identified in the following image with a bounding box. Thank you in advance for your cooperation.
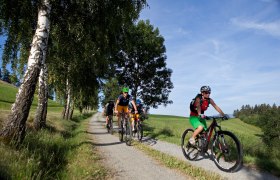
[134,141,222,180]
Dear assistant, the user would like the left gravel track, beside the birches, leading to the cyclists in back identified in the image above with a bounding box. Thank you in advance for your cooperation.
[89,113,189,180]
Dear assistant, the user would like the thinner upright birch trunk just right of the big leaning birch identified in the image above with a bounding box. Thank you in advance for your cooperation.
[33,62,49,130]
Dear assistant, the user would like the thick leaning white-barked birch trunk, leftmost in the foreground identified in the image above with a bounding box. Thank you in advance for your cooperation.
[0,0,51,145]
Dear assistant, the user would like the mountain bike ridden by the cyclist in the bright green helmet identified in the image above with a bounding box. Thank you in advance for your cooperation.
[119,112,132,146]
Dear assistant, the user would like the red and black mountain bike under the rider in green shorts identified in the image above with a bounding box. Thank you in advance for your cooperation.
[181,116,243,172]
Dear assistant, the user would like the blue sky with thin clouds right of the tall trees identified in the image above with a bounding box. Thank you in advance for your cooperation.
[140,0,280,116]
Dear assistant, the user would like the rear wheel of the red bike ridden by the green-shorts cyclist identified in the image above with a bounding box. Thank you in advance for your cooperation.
[181,129,200,161]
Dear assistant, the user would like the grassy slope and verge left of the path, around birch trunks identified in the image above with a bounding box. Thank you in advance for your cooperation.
[0,81,108,179]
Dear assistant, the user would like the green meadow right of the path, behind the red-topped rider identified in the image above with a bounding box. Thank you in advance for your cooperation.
[144,115,280,176]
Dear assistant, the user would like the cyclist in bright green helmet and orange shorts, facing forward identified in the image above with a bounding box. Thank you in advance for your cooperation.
[115,87,138,131]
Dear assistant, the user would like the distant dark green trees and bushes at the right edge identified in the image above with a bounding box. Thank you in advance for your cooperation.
[234,104,280,155]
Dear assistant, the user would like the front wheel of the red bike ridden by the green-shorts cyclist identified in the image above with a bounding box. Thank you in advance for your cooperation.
[211,131,243,172]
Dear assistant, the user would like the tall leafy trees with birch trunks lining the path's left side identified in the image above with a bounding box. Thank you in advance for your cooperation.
[0,0,173,144]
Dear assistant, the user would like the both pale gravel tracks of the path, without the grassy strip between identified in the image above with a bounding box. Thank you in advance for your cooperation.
[89,113,279,180]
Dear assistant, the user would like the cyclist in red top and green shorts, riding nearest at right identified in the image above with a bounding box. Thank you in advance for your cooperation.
[189,86,228,145]
